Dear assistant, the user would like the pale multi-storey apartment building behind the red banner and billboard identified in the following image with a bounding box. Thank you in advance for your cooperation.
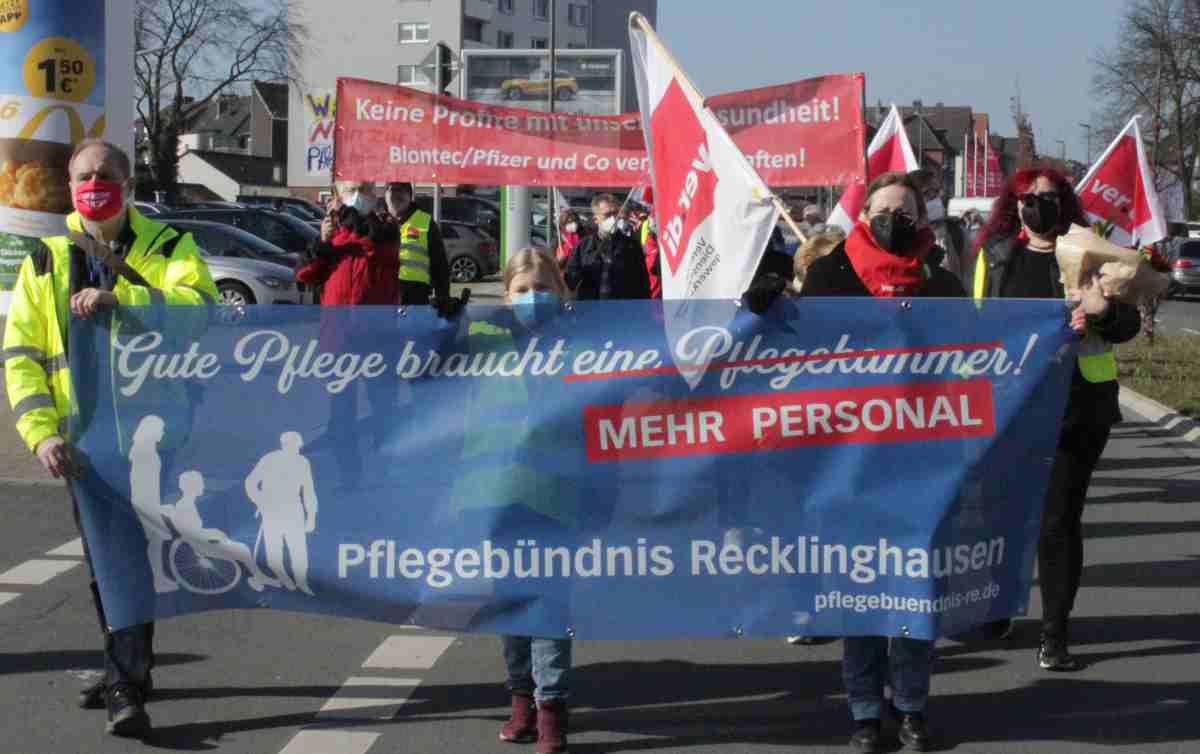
[288,0,658,197]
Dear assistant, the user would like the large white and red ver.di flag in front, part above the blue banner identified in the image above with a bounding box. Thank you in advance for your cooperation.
[629,13,779,299]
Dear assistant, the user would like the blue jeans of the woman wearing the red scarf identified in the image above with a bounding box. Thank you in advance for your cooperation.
[841,636,934,720]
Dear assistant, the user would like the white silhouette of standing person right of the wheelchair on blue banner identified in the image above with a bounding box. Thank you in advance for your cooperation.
[246,432,317,594]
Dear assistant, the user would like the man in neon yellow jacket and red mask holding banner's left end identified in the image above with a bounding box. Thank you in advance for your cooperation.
[0,139,217,736]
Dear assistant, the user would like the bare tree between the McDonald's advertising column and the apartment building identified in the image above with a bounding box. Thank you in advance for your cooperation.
[134,0,307,198]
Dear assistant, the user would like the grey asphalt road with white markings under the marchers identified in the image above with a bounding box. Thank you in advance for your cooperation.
[0,415,1200,754]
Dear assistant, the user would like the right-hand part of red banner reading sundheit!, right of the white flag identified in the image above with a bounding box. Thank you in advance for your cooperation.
[704,73,865,186]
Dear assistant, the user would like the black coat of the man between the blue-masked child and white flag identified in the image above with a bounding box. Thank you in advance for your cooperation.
[565,233,650,301]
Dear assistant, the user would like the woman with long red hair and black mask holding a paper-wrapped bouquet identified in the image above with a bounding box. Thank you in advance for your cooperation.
[974,168,1141,670]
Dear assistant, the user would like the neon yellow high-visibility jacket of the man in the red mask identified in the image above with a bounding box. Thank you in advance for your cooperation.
[0,208,217,451]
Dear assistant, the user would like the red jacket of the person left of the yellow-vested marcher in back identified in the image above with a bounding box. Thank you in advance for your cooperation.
[296,228,400,306]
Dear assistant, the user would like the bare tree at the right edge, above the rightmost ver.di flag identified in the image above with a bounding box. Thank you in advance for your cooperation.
[1092,0,1200,214]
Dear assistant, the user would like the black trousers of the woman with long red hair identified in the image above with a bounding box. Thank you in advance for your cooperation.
[1038,424,1112,639]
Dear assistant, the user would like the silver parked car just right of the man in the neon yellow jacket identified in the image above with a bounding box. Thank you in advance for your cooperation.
[169,220,314,305]
